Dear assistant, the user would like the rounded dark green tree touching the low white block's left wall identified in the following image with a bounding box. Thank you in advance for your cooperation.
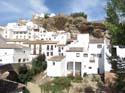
[31,54,47,74]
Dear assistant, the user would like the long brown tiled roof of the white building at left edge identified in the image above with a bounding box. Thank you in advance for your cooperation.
[0,44,27,49]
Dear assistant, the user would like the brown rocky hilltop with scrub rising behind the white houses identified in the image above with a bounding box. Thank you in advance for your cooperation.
[19,13,106,38]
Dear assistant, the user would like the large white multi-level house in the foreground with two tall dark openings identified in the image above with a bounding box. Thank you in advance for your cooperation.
[47,34,110,77]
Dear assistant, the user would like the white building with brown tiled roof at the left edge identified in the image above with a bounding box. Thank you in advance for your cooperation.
[0,44,31,65]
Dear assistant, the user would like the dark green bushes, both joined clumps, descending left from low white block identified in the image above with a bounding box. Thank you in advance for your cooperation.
[17,54,47,84]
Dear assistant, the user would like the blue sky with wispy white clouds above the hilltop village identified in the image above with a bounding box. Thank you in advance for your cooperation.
[0,0,106,24]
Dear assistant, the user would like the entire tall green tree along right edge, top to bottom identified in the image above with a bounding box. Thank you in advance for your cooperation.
[106,0,125,93]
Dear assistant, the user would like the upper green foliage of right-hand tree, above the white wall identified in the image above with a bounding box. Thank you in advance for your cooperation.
[106,0,125,45]
